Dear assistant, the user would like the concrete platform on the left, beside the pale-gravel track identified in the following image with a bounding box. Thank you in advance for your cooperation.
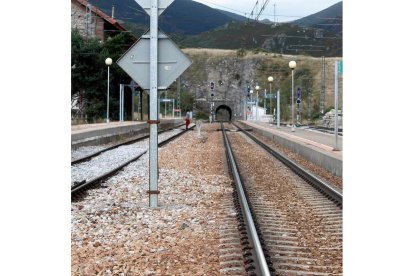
[71,118,184,149]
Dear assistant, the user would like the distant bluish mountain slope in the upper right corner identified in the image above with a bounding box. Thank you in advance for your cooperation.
[292,1,342,36]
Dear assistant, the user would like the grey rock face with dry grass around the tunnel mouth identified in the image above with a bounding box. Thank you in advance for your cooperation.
[181,49,342,123]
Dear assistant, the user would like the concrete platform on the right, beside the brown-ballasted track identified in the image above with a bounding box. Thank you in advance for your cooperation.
[239,121,342,176]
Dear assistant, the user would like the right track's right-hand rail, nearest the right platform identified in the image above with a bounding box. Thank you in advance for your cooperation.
[232,123,342,207]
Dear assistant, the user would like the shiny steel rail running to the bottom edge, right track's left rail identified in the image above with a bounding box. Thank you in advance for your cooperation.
[221,122,270,275]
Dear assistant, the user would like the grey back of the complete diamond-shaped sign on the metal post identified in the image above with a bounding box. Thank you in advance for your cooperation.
[116,31,191,90]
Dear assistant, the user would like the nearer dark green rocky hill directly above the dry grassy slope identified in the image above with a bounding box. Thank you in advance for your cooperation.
[179,21,342,56]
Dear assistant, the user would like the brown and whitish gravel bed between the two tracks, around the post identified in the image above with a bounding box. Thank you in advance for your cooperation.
[71,124,237,275]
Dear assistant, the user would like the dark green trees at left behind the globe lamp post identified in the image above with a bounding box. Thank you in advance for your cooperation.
[71,29,135,121]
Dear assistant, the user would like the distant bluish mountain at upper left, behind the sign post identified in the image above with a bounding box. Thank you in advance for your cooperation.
[89,0,244,35]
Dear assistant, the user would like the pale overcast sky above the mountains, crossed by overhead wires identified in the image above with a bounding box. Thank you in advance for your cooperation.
[194,0,340,22]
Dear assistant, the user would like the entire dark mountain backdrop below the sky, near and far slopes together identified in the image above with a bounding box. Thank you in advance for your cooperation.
[85,0,342,57]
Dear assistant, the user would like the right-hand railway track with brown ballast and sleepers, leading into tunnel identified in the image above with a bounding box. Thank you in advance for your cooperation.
[223,122,342,275]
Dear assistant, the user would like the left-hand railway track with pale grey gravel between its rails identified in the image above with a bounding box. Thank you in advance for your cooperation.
[71,125,195,199]
